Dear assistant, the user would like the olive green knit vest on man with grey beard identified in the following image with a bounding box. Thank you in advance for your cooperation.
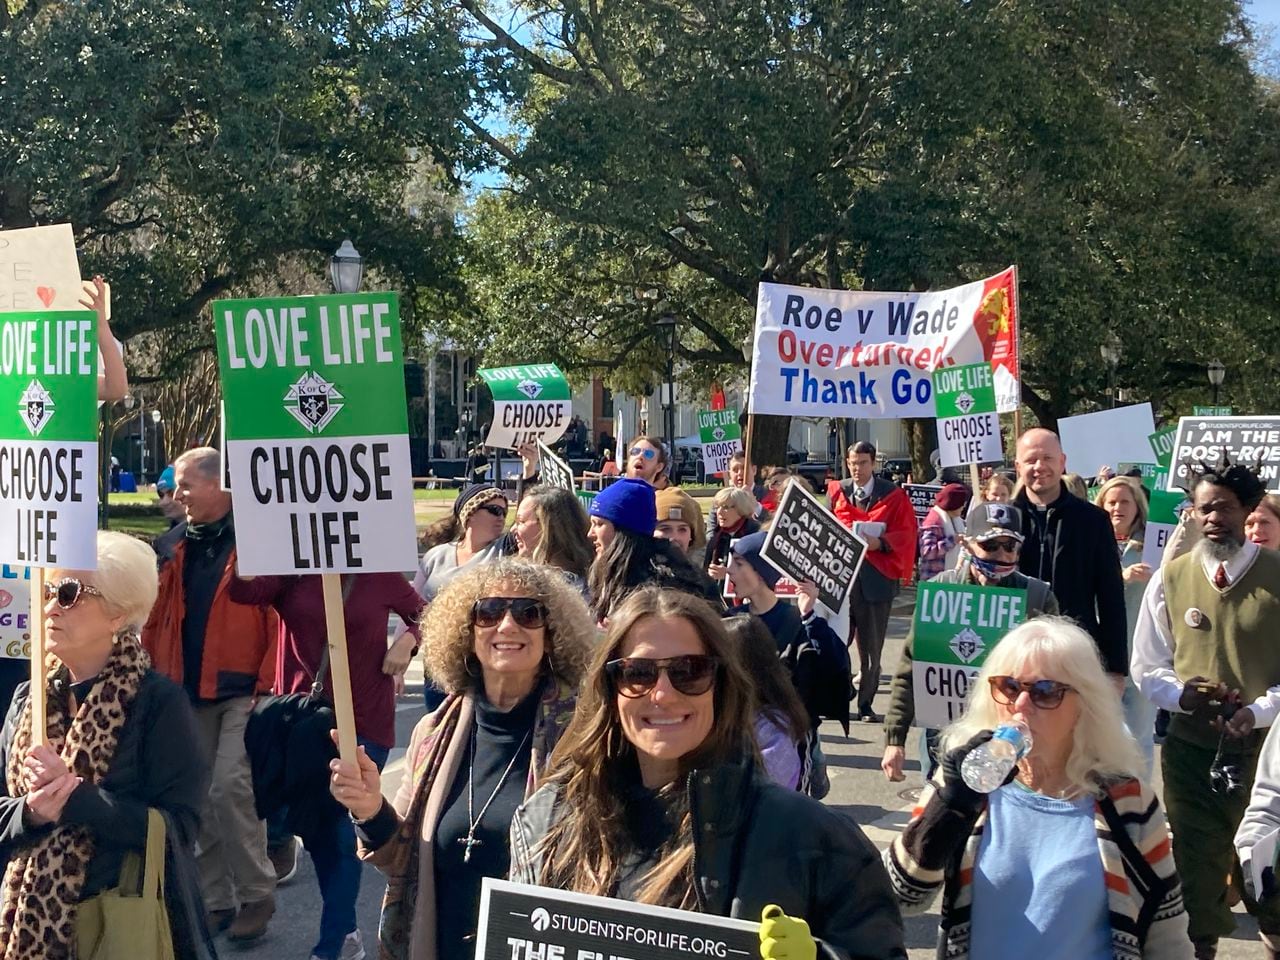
[1162,549,1280,750]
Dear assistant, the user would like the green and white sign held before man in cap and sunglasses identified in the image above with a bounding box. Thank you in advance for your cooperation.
[911,580,1027,727]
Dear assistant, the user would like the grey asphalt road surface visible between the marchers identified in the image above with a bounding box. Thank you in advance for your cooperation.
[227,596,1263,960]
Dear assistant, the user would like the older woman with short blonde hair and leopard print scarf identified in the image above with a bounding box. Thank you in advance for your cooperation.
[0,532,214,960]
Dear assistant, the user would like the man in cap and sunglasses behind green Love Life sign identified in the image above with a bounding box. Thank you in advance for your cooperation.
[881,503,1059,781]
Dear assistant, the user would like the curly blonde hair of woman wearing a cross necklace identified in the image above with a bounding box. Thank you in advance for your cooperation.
[421,558,595,694]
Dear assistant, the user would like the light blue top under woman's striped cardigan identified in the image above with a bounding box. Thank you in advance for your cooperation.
[969,783,1111,960]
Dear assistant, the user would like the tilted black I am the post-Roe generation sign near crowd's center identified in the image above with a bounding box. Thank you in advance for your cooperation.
[760,480,867,612]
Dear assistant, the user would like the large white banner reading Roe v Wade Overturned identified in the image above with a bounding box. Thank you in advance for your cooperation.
[749,268,1019,419]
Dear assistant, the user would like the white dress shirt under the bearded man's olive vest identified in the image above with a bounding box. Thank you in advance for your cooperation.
[1129,541,1280,727]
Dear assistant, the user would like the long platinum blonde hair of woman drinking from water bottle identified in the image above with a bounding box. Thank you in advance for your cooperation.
[941,617,1143,796]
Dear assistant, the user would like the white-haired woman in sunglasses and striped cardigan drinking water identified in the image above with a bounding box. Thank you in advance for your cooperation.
[884,617,1192,960]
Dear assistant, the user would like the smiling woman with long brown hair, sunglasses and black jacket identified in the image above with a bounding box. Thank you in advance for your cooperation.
[511,588,906,959]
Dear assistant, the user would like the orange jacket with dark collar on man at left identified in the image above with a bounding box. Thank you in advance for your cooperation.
[142,539,280,700]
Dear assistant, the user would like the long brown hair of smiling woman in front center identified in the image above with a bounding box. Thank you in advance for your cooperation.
[540,586,758,910]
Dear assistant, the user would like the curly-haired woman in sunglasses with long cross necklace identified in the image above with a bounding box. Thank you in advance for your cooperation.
[330,559,594,960]
